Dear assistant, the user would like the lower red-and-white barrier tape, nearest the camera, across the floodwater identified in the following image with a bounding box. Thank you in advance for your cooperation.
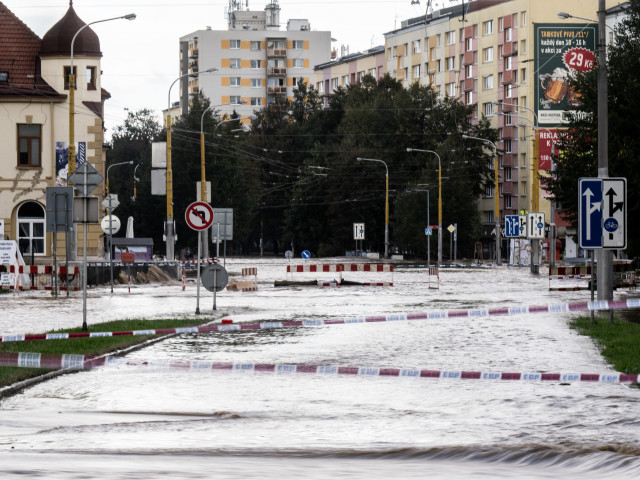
[0,352,638,383]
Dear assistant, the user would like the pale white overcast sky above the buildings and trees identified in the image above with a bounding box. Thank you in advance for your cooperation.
[2,0,459,140]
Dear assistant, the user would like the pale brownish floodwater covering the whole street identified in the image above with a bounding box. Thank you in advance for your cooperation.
[0,258,640,479]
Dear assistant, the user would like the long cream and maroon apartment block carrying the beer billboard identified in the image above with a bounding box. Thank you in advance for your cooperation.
[385,0,617,255]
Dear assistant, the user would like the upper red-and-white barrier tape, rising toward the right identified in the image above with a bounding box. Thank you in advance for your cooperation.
[0,298,640,342]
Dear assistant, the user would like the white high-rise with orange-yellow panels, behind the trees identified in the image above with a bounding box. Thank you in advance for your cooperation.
[180,0,331,123]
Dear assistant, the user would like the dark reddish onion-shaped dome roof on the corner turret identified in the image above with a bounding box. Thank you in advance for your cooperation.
[40,2,102,57]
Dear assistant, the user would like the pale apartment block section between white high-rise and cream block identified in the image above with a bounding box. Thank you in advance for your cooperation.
[314,45,385,102]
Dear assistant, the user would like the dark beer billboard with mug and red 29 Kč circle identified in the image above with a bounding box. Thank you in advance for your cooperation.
[534,23,598,126]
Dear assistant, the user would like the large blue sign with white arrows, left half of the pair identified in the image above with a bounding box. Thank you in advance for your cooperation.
[578,178,603,249]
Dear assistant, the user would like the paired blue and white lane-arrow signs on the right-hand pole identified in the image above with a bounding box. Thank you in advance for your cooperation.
[578,178,627,249]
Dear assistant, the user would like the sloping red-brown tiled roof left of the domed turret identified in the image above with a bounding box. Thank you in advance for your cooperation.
[0,2,66,99]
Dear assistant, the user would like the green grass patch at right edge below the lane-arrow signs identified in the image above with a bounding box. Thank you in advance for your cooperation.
[570,316,640,373]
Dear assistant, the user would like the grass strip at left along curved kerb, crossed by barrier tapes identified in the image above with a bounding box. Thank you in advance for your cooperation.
[0,319,209,387]
